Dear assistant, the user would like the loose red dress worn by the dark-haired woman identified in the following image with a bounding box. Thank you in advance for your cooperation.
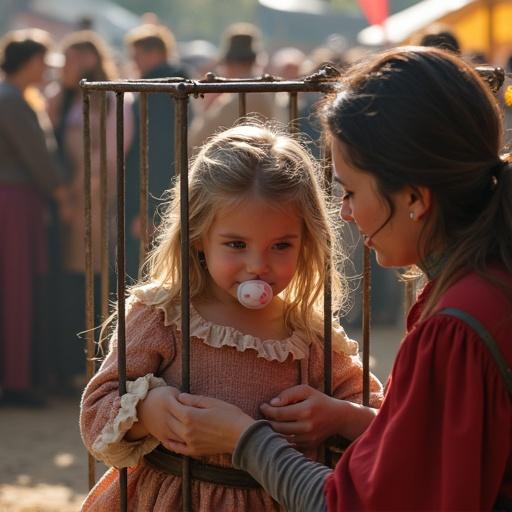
[325,272,512,511]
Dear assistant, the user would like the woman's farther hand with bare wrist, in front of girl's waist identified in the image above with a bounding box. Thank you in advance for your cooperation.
[260,385,377,448]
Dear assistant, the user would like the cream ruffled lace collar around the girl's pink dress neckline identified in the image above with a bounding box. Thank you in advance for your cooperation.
[132,285,358,363]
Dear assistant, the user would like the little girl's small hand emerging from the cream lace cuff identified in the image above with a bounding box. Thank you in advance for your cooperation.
[125,386,185,448]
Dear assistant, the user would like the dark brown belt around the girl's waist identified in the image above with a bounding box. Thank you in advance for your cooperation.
[144,445,261,489]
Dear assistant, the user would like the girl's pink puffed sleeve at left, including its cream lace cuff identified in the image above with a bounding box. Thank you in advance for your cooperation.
[80,301,175,467]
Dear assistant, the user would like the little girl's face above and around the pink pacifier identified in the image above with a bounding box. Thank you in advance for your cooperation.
[198,198,302,302]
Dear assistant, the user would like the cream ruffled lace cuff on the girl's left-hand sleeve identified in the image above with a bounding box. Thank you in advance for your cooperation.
[91,373,167,468]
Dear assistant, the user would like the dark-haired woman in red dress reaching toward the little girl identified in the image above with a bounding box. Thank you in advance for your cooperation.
[155,47,512,512]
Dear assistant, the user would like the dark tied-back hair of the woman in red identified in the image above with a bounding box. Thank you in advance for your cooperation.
[323,47,512,317]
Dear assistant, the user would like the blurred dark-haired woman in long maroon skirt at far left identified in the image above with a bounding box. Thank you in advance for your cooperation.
[0,29,66,405]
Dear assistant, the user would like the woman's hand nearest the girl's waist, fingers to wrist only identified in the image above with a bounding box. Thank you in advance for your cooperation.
[260,385,346,449]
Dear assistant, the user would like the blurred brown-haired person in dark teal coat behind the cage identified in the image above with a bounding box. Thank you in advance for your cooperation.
[125,23,187,279]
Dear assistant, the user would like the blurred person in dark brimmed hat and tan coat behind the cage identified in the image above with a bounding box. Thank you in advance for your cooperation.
[189,23,275,151]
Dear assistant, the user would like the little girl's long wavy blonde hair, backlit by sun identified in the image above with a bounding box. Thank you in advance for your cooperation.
[133,122,344,340]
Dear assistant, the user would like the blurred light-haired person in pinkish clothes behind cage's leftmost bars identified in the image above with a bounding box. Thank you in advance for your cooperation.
[46,30,133,393]
